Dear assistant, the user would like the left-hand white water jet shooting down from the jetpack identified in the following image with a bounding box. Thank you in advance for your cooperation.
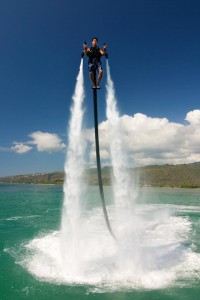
[61,59,85,274]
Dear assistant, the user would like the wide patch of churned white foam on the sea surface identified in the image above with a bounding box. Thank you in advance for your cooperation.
[16,205,200,291]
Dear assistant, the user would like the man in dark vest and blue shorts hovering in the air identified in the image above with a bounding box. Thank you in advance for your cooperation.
[83,37,106,89]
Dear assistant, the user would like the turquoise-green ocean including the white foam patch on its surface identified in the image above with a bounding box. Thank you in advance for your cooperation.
[0,184,200,300]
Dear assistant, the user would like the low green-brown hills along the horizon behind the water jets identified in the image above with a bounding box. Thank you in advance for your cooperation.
[0,162,200,188]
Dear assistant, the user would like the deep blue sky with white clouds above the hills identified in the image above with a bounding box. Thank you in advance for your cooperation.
[0,0,200,176]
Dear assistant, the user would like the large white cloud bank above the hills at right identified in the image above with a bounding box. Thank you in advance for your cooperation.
[86,110,200,166]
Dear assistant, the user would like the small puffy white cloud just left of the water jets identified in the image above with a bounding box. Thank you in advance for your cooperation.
[28,131,66,152]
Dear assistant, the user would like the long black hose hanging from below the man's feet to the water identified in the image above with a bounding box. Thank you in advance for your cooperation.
[93,89,116,240]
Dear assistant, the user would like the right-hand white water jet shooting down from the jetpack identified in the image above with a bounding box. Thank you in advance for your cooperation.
[106,61,141,273]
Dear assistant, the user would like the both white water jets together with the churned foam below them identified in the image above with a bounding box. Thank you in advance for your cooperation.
[17,62,200,293]
